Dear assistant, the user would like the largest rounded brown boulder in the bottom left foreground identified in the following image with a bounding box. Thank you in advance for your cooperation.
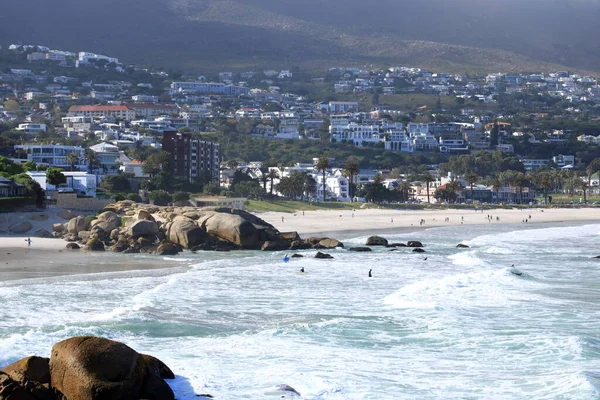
[50,336,175,400]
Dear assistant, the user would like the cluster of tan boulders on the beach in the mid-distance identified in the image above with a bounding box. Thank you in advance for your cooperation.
[52,201,344,255]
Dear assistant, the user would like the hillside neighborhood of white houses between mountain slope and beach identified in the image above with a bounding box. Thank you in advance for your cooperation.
[0,45,600,203]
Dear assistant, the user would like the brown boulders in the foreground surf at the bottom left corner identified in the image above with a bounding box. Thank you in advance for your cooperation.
[0,336,175,400]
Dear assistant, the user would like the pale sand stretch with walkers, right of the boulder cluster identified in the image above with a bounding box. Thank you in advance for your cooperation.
[258,208,600,236]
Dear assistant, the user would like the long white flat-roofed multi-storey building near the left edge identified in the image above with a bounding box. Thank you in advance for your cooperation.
[15,144,87,170]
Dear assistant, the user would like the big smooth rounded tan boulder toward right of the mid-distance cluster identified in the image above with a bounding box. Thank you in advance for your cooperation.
[202,213,260,249]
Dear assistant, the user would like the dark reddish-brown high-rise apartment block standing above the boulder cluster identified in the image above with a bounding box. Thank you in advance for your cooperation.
[162,131,221,184]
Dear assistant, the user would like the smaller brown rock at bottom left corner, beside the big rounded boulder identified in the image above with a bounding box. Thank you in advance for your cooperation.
[0,356,57,400]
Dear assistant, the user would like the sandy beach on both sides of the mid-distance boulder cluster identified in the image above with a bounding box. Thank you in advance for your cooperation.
[0,208,600,281]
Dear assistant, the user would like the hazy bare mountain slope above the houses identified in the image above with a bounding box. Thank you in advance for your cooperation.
[0,0,600,72]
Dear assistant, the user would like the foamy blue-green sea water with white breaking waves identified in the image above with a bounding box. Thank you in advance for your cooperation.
[0,224,600,399]
